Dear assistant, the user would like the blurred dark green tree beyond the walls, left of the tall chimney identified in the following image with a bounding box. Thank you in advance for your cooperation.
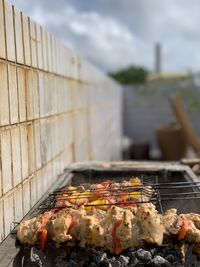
[109,66,148,85]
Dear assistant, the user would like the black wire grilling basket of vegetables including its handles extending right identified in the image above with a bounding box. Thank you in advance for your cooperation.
[38,176,200,217]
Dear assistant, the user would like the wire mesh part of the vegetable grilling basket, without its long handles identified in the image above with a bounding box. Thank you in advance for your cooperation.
[36,177,162,215]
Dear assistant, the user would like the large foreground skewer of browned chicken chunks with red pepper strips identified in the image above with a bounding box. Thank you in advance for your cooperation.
[17,204,164,254]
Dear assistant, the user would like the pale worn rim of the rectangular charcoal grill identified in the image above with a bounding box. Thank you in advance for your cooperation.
[0,162,199,267]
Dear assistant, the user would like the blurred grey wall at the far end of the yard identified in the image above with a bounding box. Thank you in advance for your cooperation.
[123,84,200,148]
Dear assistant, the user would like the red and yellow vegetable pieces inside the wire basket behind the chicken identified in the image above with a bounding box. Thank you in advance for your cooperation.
[55,178,152,210]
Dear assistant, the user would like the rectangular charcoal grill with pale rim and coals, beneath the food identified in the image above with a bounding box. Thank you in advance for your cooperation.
[0,162,200,267]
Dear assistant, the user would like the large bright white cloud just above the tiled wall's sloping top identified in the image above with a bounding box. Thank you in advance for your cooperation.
[28,6,149,71]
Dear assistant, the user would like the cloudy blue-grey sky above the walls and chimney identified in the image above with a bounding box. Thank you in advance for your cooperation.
[11,0,200,72]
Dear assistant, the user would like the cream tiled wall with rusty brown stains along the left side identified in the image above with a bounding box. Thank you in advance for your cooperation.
[0,0,121,241]
